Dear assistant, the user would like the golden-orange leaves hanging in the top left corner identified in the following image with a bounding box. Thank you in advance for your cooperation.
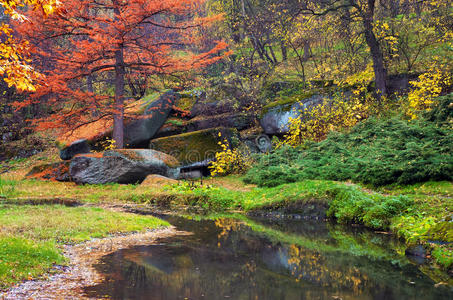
[0,0,60,91]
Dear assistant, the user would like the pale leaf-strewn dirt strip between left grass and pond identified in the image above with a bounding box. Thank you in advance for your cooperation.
[0,227,190,300]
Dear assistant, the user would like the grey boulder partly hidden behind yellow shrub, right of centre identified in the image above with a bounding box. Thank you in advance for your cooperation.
[260,95,329,135]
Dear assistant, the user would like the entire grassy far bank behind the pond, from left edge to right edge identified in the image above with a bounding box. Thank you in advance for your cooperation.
[0,169,453,269]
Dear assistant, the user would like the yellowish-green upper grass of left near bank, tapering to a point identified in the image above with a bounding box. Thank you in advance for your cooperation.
[0,205,168,243]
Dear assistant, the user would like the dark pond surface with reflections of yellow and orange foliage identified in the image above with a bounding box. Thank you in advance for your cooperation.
[87,219,452,300]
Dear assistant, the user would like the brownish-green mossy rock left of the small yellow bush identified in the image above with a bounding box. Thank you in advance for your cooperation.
[150,127,238,164]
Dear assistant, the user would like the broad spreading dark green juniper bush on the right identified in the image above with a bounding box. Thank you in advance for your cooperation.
[244,102,453,187]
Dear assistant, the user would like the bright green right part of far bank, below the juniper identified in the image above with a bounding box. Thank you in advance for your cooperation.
[156,177,453,270]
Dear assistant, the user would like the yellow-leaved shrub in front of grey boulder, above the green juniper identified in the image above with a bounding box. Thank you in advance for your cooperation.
[276,96,370,147]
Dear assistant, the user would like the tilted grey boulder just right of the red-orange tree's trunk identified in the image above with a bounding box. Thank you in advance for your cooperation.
[124,91,179,146]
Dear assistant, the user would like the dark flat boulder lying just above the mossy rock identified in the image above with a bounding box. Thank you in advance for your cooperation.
[187,113,255,131]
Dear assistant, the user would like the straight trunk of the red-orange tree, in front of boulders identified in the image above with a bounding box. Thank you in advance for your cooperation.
[113,45,125,149]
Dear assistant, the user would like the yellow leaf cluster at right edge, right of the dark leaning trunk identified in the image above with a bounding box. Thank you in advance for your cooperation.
[406,69,452,119]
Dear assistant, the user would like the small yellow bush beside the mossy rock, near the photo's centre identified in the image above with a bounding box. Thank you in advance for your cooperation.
[209,133,252,176]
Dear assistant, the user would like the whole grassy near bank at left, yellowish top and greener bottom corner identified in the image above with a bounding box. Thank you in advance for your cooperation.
[0,205,169,288]
